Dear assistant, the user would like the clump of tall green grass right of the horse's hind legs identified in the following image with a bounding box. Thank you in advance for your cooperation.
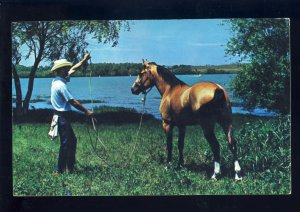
[237,116,291,193]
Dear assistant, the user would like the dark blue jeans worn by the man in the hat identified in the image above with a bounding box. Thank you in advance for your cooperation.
[56,112,77,173]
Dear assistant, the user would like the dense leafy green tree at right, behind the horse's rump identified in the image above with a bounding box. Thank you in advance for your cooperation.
[226,19,290,114]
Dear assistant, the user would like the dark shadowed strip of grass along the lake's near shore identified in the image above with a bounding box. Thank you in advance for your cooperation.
[13,109,155,125]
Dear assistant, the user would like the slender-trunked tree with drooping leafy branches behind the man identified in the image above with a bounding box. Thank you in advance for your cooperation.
[12,20,129,114]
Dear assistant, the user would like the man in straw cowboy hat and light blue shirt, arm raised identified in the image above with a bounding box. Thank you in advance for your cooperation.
[51,53,93,175]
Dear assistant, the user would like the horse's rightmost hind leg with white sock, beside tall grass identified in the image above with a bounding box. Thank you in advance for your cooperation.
[220,119,242,180]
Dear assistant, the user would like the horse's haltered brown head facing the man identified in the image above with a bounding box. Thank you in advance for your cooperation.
[131,60,155,95]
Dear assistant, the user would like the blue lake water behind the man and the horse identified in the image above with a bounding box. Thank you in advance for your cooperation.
[12,74,274,119]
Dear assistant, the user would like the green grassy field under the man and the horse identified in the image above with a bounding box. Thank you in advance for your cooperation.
[12,108,291,196]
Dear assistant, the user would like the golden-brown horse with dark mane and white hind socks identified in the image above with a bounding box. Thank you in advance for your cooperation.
[131,60,242,180]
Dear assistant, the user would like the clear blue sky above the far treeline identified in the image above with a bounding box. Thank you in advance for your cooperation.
[21,19,238,65]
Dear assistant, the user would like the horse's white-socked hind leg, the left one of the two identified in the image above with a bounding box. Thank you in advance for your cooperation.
[201,121,221,180]
